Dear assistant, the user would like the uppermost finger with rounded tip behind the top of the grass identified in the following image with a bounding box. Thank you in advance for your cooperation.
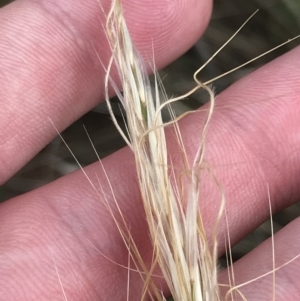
[0,0,211,183]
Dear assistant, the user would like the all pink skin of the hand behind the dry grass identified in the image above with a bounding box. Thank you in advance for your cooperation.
[0,0,300,301]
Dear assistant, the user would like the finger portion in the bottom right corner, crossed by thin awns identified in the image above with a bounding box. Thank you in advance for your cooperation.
[220,218,300,301]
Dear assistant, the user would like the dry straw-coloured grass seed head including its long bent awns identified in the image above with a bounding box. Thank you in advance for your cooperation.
[101,0,300,301]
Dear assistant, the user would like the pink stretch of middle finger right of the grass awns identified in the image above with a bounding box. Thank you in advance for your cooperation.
[199,47,300,242]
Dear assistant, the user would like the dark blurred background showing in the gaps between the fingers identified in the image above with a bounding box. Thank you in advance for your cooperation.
[0,0,300,261]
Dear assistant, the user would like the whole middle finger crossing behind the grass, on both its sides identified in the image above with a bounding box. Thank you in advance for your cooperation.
[0,44,300,300]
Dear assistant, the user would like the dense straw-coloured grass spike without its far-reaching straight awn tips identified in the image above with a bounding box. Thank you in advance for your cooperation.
[106,0,224,301]
